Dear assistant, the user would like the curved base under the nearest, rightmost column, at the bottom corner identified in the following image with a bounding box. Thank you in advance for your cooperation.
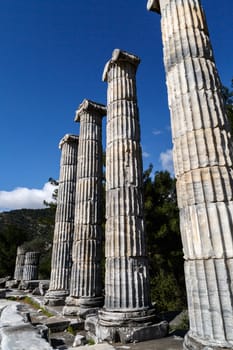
[183,331,233,350]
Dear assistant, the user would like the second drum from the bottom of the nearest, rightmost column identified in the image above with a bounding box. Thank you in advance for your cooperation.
[180,201,233,259]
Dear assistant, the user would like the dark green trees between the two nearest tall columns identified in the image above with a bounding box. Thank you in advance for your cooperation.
[144,165,186,311]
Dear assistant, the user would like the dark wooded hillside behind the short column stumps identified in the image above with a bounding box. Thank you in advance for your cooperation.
[0,207,55,278]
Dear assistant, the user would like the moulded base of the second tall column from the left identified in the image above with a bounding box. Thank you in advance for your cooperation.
[62,296,104,318]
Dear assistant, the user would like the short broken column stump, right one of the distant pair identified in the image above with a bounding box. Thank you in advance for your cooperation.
[23,252,40,281]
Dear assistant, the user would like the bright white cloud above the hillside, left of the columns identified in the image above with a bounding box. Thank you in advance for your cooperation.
[0,182,55,211]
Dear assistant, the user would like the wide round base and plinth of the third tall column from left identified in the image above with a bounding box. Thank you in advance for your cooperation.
[85,309,169,344]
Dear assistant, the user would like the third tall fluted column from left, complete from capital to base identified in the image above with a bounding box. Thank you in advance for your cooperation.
[90,49,167,342]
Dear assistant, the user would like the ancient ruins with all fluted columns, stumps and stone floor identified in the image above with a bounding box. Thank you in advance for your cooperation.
[0,0,233,350]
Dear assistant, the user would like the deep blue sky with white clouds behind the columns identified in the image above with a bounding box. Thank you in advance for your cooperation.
[0,0,233,210]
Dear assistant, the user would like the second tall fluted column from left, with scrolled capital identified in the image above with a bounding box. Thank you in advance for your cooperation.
[63,99,106,316]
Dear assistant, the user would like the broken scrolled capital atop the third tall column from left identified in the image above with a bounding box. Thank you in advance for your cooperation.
[102,49,140,81]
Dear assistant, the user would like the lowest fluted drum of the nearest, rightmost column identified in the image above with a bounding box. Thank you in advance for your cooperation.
[185,259,233,346]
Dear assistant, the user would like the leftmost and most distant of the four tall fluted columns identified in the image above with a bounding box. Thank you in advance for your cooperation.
[45,134,79,305]
